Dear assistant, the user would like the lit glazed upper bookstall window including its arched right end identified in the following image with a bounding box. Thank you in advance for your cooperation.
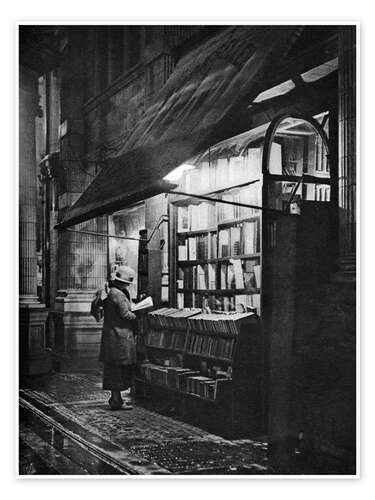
[165,117,331,316]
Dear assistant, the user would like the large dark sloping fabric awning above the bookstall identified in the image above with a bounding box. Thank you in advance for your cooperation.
[59,25,302,228]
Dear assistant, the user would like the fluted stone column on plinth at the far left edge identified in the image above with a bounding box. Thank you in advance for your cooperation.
[19,66,50,380]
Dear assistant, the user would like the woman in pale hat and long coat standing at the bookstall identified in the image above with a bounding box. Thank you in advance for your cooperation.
[99,266,137,410]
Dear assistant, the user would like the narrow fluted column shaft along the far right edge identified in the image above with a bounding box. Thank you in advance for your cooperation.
[338,26,356,281]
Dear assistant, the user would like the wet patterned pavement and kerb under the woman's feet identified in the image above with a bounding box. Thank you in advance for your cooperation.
[20,373,267,475]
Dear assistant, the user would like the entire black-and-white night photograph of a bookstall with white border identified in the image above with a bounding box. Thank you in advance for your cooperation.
[16,21,360,478]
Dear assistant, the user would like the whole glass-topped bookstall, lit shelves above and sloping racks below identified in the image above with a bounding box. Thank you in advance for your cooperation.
[139,113,335,437]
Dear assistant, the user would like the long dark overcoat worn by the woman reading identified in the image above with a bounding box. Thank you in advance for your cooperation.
[99,287,136,365]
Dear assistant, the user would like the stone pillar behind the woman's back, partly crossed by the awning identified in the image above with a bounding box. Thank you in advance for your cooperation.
[53,28,107,371]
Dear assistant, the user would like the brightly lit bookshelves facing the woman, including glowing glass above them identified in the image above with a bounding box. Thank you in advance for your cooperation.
[170,146,262,315]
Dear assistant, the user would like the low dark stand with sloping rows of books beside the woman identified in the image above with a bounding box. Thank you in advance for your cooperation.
[137,308,263,437]
